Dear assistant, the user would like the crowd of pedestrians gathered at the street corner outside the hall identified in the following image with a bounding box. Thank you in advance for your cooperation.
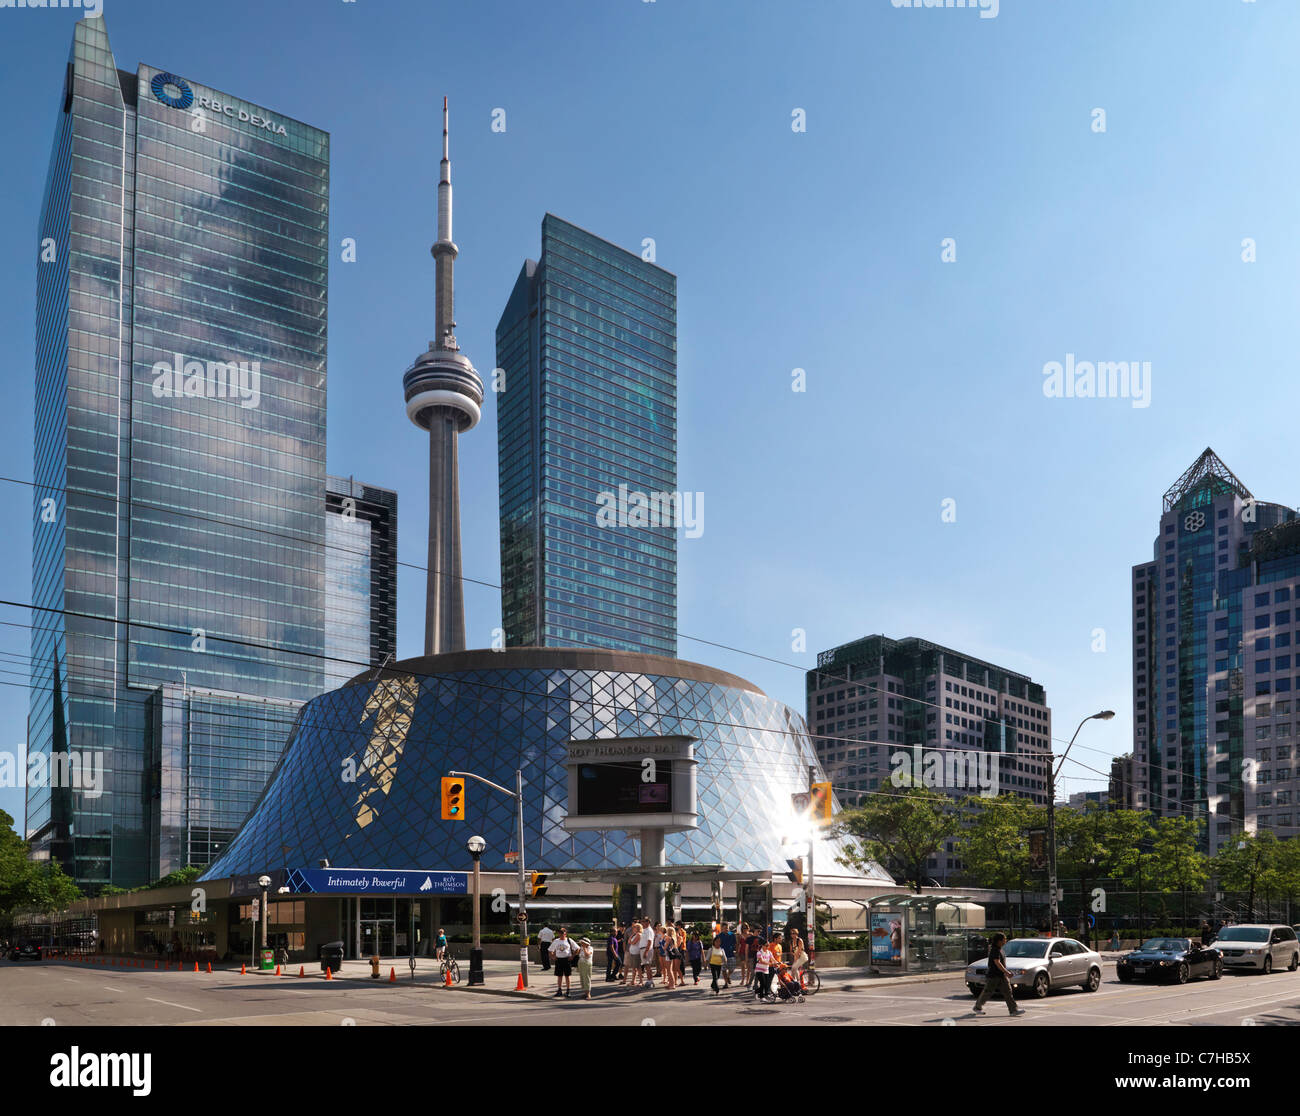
[537,918,809,1000]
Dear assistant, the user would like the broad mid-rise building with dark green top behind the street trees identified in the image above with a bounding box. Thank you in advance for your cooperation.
[806,635,1052,882]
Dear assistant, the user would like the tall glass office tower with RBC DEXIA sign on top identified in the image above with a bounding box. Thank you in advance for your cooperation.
[27,18,329,890]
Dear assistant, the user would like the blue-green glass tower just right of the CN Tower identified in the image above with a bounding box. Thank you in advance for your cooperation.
[494,213,677,656]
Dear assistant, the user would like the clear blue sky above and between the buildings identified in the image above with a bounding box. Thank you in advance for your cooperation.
[0,0,1300,818]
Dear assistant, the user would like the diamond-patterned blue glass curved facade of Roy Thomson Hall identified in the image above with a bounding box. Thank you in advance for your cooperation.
[205,650,891,882]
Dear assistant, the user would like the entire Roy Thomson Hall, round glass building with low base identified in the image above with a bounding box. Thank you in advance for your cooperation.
[25,648,1003,964]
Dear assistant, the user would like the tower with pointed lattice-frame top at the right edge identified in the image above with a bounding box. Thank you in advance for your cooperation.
[1132,449,1300,852]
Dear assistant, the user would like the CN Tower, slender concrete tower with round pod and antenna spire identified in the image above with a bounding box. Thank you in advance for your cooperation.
[402,98,484,654]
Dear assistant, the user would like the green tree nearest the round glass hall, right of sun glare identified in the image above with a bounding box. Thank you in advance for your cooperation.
[835,786,958,894]
